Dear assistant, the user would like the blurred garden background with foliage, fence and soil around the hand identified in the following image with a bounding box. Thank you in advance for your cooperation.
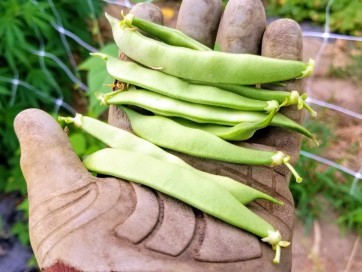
[0,0,362,272]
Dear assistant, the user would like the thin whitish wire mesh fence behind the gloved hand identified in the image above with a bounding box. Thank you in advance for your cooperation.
[0,0,362,189]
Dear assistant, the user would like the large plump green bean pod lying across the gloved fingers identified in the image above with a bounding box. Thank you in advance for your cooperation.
[106,14,314,85]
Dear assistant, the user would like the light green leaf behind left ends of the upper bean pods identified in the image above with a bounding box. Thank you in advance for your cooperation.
[78,43,118,117]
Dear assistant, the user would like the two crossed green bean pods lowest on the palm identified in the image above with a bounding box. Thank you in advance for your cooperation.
[58,114,290,263]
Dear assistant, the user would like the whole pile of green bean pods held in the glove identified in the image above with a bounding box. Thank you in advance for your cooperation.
[60,11,316,263]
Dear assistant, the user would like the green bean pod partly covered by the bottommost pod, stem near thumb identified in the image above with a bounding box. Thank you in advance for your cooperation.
[58,113,283,205]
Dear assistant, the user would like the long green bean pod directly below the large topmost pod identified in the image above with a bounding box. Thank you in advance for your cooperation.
[92,53,279,112]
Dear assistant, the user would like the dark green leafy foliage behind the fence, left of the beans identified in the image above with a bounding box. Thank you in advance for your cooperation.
[0,0,103,249]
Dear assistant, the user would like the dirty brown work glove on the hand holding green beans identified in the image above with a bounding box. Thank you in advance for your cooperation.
[14,0,302,271]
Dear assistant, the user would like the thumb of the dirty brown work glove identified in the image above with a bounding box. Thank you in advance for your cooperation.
[14,109,90,205]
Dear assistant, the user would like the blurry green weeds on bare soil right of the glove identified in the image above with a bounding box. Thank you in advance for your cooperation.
[290,121,362,234]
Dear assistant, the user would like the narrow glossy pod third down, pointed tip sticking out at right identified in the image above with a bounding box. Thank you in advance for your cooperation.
[98,89,314,143]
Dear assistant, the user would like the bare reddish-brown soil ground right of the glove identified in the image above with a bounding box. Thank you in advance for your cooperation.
[292,38,362,272]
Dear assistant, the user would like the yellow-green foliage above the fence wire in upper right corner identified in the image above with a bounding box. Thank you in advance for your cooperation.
[266,0,362,36]
